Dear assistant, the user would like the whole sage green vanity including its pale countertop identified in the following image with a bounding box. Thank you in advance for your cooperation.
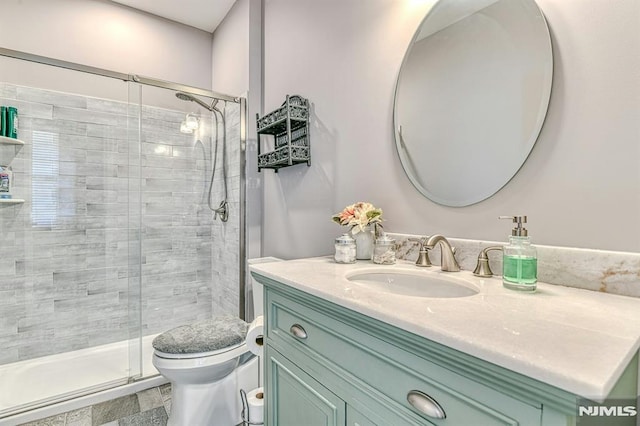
[251,258,640,426]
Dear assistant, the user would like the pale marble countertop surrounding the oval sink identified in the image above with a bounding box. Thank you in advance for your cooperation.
[250,257,640,401]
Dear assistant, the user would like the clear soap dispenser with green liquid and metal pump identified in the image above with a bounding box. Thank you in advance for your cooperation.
[499,216,538,292]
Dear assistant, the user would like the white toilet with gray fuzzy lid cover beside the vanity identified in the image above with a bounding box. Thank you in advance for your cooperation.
[153,258,279,426]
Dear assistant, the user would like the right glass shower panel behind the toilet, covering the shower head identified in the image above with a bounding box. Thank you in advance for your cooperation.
[123,83,242,379]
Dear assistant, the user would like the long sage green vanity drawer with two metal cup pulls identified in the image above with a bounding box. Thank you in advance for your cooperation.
[266,289,541,426]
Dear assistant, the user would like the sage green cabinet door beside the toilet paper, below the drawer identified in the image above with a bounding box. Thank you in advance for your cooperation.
[265,345,346,426]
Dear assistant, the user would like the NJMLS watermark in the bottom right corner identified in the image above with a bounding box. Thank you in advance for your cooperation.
[576,398,640,426]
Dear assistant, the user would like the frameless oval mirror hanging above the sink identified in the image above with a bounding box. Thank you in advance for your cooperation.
[394,0,553,207]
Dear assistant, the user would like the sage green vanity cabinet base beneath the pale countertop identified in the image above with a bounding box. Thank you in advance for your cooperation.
[254,273,637,426]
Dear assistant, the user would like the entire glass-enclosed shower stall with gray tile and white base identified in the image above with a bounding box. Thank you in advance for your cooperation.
[0,49,246,423]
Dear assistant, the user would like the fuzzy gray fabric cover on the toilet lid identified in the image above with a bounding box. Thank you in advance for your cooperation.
[153,315,249,354]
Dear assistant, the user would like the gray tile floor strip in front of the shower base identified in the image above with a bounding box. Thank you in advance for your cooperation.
[21,384,171,426]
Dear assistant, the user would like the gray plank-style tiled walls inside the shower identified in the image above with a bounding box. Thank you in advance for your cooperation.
[0,82,240,364]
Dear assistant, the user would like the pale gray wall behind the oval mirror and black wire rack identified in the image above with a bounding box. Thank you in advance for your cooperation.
[263,0,640,258]
